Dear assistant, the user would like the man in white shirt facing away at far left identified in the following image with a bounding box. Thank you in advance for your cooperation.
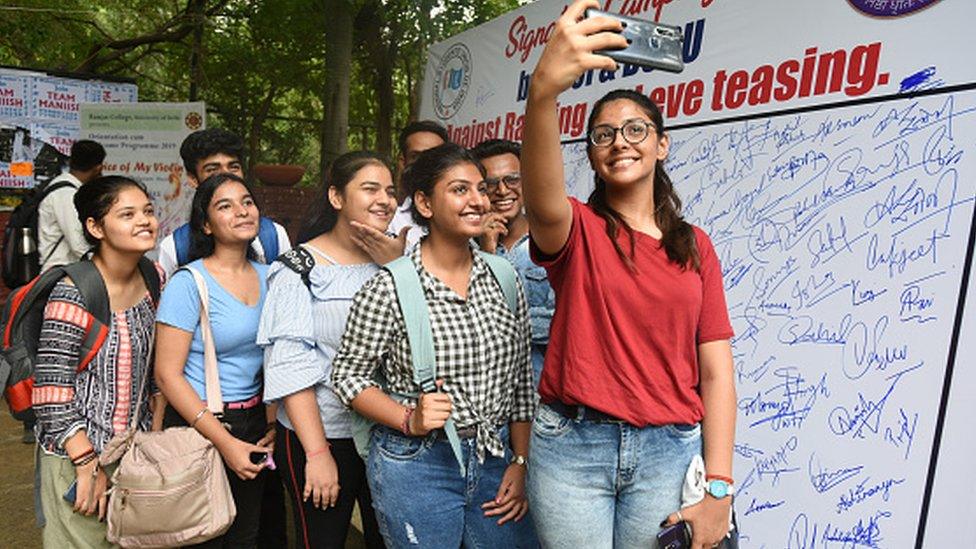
[37,139,105,272]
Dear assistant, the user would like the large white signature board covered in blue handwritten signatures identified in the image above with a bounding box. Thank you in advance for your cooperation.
[421,0,976,549]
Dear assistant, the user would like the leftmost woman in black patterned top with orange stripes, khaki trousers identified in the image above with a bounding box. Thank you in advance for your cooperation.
[32,176,158,547]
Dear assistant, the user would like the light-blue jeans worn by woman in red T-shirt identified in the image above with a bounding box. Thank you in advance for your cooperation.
[528,404,701,549]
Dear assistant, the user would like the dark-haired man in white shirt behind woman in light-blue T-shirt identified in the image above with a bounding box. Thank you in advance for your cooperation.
[159,128,291,277]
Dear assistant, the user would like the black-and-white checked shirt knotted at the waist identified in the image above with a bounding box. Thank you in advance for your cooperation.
[332,246,535,460]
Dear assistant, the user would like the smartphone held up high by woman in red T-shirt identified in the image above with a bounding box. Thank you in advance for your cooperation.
[585,9,685,72]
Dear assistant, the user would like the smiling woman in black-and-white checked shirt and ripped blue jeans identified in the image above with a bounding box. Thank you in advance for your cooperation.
[332,144,537,547]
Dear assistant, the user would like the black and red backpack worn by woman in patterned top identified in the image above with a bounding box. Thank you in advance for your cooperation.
[0,257,160,421]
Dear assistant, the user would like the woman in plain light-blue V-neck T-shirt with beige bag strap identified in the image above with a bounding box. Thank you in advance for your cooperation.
[156,173,274,548]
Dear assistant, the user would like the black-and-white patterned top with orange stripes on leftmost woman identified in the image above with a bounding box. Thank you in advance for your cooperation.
[32,280,156,457]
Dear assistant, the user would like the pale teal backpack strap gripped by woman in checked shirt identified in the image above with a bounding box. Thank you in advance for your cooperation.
[383,256,465,476]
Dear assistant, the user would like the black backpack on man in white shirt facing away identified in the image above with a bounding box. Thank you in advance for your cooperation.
[0,180,75,289]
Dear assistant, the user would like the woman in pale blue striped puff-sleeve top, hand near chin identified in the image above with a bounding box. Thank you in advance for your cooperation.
[258,152,390,548]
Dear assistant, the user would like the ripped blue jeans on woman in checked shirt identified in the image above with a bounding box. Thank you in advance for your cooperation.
[367,426,539,549]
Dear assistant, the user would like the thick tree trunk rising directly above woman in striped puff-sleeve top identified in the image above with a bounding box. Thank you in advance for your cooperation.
[319,0,355,174]
